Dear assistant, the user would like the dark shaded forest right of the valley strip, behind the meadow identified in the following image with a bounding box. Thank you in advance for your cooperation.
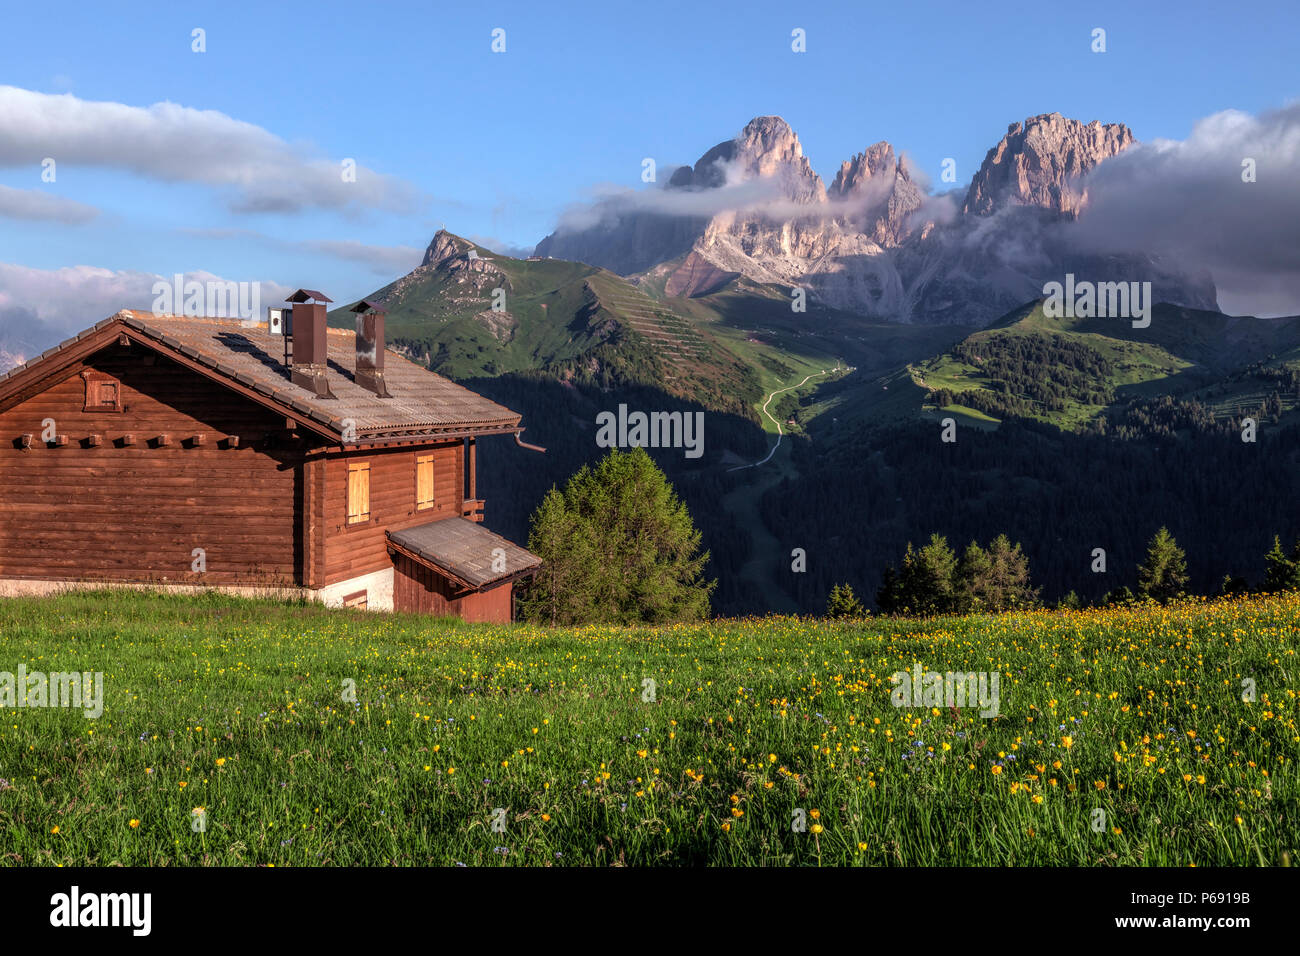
[763,421,1300,611]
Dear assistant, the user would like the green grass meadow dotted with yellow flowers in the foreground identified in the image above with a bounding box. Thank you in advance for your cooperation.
[0,592,1300,866]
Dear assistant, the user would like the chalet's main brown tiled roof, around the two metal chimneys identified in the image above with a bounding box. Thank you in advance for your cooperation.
[0,310,520,440]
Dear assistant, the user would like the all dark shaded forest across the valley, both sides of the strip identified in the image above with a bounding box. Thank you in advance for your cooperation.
[464,375,1300,615]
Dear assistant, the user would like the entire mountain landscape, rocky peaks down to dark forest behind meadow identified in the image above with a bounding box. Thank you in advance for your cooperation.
[330,113,1300,614]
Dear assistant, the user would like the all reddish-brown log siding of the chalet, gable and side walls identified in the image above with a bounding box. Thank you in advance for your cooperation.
[0,339,493,600]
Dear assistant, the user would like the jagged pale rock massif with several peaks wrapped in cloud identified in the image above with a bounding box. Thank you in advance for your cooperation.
[536,113,1217,324]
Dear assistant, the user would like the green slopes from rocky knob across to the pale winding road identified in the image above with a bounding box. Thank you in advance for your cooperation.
[330,232,969,429]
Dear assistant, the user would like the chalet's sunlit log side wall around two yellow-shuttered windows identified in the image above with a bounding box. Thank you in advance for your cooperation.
[320,441,464,584]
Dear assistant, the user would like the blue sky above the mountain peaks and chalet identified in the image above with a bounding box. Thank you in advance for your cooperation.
[0,1,1300,324]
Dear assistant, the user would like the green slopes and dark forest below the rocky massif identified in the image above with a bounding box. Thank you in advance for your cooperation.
[317,233,1300,613]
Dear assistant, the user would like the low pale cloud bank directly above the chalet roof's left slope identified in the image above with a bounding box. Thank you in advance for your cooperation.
[0,263,294,371]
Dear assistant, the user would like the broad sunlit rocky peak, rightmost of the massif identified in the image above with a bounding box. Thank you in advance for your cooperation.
[962,113,1138,219]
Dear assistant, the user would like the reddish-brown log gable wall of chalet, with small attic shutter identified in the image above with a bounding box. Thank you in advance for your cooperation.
[0,345,306,584]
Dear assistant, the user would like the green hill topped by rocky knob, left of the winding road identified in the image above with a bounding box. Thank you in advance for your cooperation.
[330,233,761,411]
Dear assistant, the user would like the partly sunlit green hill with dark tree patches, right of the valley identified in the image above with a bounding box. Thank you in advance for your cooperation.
[821,303,1300,429]
